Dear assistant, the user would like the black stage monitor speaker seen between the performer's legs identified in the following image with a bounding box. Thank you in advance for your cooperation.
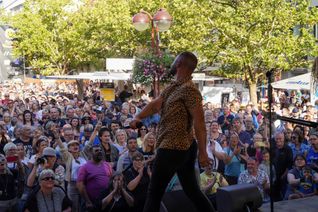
[160,190,201,212]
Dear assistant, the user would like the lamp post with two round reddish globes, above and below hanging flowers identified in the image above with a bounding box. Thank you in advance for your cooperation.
[132,9,172,97]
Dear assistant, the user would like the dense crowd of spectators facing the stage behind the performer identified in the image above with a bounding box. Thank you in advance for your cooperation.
[0,78,318,212]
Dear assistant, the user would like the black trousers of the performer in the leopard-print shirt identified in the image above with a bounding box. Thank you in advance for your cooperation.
[143,141,215,212]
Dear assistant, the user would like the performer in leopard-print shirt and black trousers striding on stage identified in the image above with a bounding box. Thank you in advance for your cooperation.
[130,52,214,212]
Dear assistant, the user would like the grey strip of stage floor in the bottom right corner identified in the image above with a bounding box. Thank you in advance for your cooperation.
[259,196,318,212]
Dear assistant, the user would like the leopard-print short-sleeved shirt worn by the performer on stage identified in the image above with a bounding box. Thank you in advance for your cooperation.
[157,79,202,150]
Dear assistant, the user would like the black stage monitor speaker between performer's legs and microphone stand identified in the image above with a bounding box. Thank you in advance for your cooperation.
[216,184,263,212]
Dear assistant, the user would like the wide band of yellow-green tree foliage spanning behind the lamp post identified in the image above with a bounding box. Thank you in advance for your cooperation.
[5,0,318,103]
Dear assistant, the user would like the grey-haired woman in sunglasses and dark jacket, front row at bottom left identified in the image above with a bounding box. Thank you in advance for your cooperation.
[23,169,72,212]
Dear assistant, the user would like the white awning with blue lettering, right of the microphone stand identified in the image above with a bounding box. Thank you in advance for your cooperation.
[272,73,311,90]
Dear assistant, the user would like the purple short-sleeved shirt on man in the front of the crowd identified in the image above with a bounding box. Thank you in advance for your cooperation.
[77,161,112,201]
